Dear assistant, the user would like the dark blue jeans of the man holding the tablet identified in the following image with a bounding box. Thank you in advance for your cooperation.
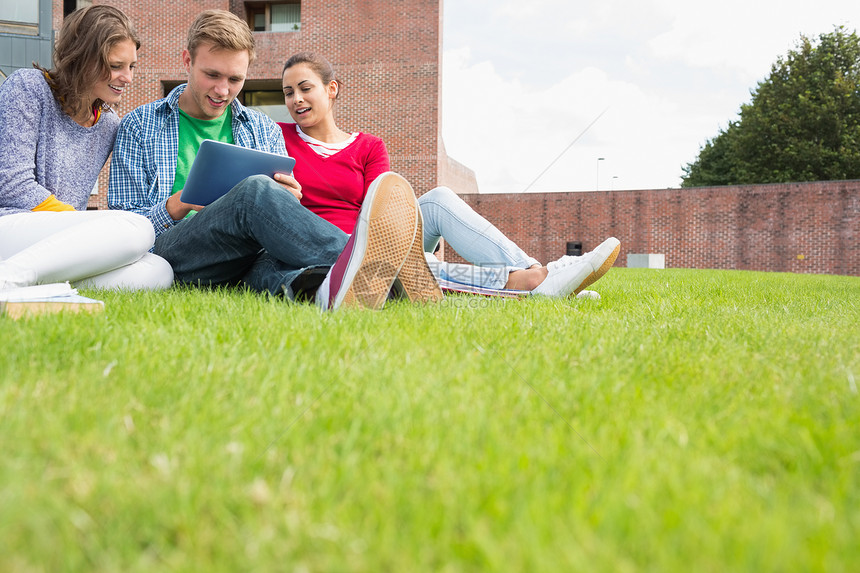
[153,175,347,298]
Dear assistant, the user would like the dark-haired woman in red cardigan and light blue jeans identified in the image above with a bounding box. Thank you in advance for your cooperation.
[279,52,620,297]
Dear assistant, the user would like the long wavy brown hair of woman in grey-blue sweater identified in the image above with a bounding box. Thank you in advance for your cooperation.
[33,5,140,117]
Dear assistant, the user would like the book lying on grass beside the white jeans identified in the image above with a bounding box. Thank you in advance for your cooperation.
[0,282,105,320]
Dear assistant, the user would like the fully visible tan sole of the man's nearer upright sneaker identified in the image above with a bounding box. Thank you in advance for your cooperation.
[332,174,418,309]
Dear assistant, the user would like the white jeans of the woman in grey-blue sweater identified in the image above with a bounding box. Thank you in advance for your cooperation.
[0,211,173,290]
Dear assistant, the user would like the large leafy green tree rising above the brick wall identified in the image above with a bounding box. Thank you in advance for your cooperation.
[681,27,860,187]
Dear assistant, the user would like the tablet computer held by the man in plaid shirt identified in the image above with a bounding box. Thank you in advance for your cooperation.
[181,139,296,205]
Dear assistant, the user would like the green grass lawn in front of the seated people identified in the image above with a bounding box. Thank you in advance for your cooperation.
[0,269,860,572]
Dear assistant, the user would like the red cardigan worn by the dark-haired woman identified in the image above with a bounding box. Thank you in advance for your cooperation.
[278,123,390,233]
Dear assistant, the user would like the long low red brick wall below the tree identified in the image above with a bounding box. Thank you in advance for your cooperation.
[454,181,860,276]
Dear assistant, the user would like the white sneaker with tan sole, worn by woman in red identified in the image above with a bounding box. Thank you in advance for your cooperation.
[531,237,621,297]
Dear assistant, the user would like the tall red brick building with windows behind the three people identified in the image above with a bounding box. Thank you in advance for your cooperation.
[0,0,477,208]
